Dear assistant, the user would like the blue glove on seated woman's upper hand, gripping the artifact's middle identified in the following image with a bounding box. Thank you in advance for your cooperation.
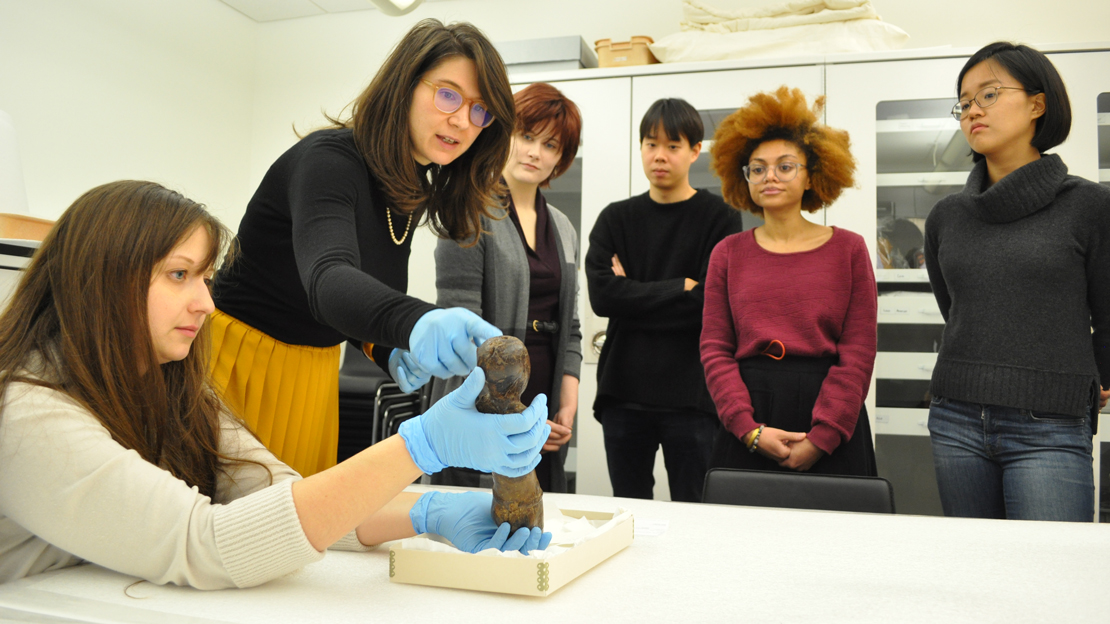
[398,368,552,476]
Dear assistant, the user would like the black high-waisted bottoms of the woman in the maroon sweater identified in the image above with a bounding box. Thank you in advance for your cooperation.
[709,355,878,476]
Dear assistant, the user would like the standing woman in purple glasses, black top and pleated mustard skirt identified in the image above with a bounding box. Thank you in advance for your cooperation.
[212,19,537,476]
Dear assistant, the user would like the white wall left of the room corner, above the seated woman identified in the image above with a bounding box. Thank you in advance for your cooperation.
[0,0,259,224]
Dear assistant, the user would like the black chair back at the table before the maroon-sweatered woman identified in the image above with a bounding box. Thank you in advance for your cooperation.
[702,469,895,513]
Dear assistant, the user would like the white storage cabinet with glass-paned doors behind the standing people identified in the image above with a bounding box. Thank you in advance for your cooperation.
[513,43,1110,513]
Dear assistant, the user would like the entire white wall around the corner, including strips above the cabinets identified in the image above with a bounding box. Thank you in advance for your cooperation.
[0,0,1110,223]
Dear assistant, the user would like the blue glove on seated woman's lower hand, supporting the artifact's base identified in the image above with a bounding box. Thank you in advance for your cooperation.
[408,492,552,554]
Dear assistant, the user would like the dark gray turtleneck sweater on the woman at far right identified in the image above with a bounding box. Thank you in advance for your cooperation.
[925,154,1110,426]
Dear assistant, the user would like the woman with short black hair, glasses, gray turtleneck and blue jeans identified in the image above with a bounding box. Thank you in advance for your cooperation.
[925,42,1110,522]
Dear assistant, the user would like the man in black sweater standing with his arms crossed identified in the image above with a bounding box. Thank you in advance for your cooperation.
[586,99,744,502]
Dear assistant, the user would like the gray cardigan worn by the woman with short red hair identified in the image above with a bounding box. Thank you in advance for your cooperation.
[432,204,582,415]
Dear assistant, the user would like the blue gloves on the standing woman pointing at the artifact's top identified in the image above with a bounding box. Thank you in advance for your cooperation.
[389,308,501,392]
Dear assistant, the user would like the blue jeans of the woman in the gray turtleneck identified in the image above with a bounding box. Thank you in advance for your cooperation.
[929,396,1094,522]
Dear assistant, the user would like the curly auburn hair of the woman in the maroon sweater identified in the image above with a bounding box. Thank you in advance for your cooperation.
[709,85,856,217]
